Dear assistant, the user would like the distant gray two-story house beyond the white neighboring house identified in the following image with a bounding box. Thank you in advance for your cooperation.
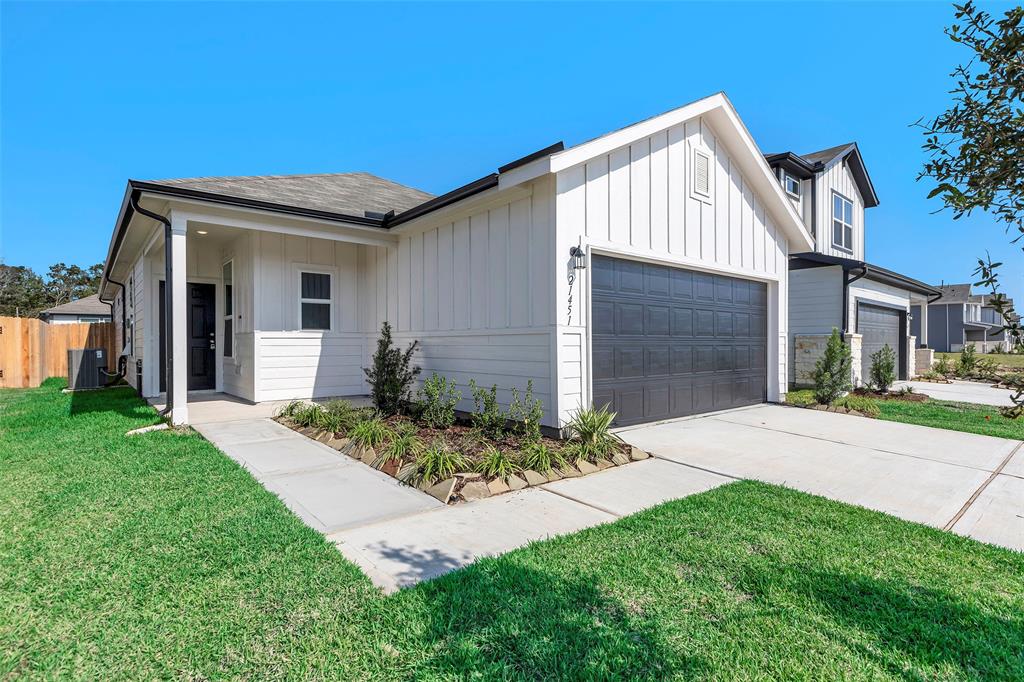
[910,284,1019,352]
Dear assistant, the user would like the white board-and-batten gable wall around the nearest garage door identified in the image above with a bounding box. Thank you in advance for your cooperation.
[555,118,788,423]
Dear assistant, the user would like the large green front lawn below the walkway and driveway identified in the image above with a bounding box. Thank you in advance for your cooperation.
[0,382,1024,680]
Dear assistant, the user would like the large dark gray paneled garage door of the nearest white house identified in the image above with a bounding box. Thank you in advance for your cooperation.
[591,256,768,426]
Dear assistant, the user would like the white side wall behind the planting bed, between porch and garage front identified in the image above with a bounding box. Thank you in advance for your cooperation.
[357,180,554,424]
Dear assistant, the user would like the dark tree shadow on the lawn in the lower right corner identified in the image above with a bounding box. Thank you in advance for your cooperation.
[761,566,1024,680]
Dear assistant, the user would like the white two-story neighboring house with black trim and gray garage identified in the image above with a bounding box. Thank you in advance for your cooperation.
[765,142,937,385]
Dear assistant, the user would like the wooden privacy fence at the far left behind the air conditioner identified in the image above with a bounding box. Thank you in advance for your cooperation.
[0,317,119,388]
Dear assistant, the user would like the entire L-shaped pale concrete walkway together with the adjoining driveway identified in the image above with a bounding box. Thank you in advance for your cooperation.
[197,406,1024,591]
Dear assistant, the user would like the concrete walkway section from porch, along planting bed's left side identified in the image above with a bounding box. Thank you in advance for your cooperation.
[195,419,443,532]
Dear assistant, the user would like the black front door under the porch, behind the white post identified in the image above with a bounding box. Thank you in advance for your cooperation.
[160,282,217,391]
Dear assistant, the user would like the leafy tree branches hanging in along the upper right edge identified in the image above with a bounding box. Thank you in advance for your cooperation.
[918,1,1024,417]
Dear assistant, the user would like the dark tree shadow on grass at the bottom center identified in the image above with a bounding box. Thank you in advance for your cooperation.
[406,558,708,680]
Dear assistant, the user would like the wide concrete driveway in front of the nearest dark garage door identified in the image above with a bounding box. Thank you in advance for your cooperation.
[620,406,1024,550]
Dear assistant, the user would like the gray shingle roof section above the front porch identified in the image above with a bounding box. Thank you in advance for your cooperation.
[147,173,433,216]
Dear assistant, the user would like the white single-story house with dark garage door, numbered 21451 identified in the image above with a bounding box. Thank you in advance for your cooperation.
[101,94,815,427]
